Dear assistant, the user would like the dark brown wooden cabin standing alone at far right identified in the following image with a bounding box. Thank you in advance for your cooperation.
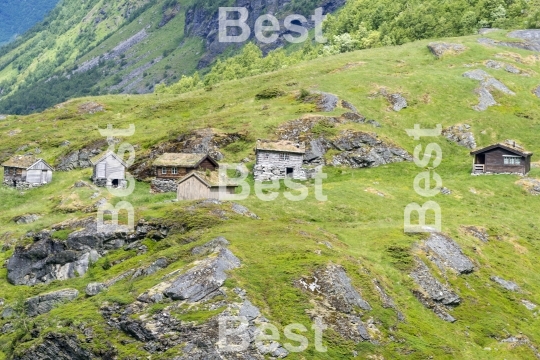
[471,141,533,175]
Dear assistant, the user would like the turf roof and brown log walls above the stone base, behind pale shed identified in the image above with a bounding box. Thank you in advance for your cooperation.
[153,153,219,180]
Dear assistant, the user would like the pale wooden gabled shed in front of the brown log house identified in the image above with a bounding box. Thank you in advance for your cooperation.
[177,171,238,201]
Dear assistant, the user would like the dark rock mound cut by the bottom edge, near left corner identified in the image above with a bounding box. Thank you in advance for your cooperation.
[13,333,98,360]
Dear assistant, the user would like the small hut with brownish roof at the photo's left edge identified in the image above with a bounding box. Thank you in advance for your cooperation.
[2,155,53,187]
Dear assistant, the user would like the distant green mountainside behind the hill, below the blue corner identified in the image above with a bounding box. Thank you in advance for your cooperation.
[0,0,344,114]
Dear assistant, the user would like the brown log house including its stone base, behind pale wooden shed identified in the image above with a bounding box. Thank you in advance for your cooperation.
[151,153,219,193]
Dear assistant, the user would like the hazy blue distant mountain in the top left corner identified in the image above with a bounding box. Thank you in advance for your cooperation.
[0,0,58,45]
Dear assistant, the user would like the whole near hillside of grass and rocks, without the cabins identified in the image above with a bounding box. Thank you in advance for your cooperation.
[0,30,540,360]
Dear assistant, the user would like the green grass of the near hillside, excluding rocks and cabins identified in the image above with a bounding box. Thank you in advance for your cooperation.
[0,30,540,359]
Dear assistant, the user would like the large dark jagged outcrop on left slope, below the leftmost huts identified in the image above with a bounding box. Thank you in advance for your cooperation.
[7,218,169,285]
